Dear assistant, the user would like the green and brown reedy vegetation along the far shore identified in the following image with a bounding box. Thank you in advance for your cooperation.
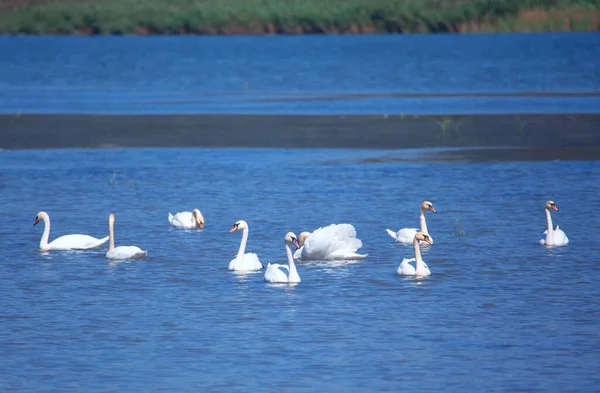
[0,0,600,35]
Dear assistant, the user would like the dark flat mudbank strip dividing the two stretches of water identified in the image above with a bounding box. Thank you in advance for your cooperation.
[0,114,600,161]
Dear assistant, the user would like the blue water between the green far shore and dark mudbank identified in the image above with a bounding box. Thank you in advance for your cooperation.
[0,33,600,114]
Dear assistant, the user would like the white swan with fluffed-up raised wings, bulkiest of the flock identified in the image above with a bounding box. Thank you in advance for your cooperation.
[294,224,368,261]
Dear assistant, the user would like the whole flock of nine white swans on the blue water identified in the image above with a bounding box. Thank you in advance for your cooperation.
[33,201,569,284]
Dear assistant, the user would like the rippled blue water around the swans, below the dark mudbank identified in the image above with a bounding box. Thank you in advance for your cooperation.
[0,149,600,392]
